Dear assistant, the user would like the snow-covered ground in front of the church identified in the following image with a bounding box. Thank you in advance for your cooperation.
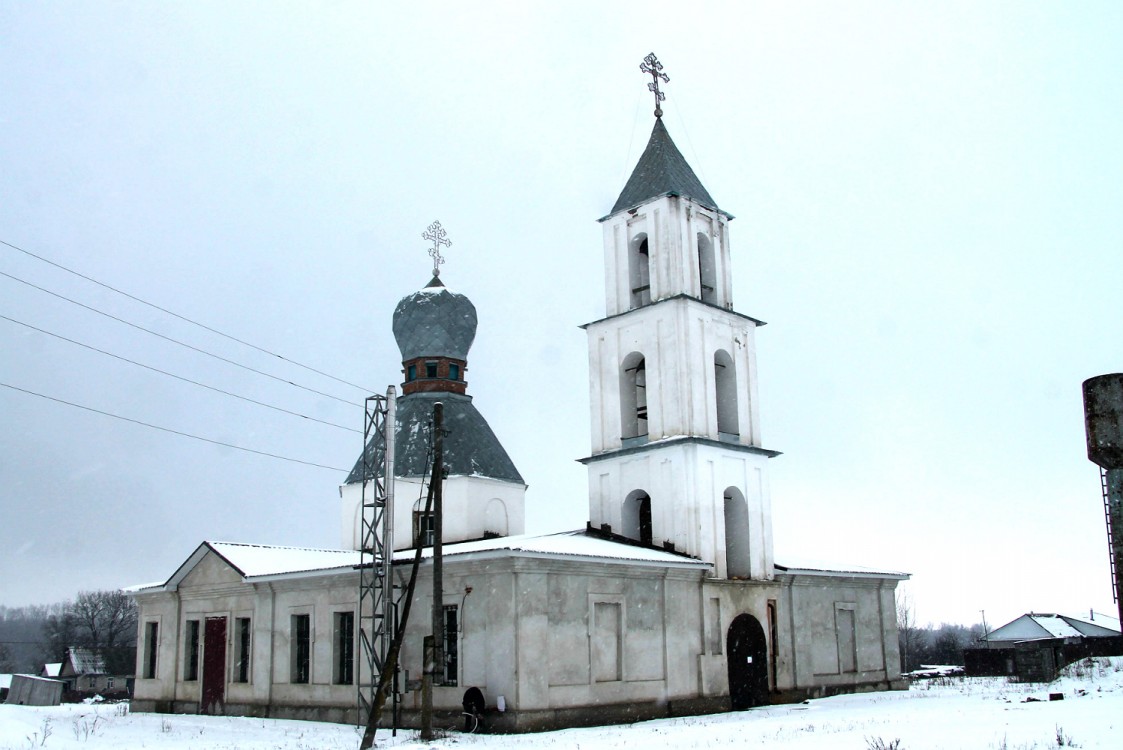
[0,657,1123,750]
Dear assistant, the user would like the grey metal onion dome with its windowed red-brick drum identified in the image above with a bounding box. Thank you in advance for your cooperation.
[393,276,476,395]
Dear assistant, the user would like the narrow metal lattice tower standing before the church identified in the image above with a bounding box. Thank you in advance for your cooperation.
[355,385,398,724]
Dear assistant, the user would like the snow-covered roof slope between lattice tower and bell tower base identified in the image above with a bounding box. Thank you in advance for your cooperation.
[394,529,710,568]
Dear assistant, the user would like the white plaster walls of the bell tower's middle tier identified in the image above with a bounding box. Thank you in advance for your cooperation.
[586,298,761,455]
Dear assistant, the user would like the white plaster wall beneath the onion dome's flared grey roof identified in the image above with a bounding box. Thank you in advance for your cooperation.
[339,475,527,550]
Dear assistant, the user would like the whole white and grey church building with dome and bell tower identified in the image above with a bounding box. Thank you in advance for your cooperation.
[127,84,907,731]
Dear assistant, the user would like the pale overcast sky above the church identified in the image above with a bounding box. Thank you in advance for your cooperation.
[0,0,1123,626]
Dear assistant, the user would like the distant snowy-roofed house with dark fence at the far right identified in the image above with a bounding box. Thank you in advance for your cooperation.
[964,612,1123,683]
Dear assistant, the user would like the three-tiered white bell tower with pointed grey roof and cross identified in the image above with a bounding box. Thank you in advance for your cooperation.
[582,55,778,579]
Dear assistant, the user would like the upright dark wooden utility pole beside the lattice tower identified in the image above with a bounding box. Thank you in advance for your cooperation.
[421,401,445,742]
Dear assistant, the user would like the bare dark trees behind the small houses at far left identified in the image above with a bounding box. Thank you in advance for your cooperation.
[0,591,137,675]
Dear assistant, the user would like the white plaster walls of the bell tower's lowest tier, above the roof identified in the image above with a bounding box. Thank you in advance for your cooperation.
[588,441,773,579]
